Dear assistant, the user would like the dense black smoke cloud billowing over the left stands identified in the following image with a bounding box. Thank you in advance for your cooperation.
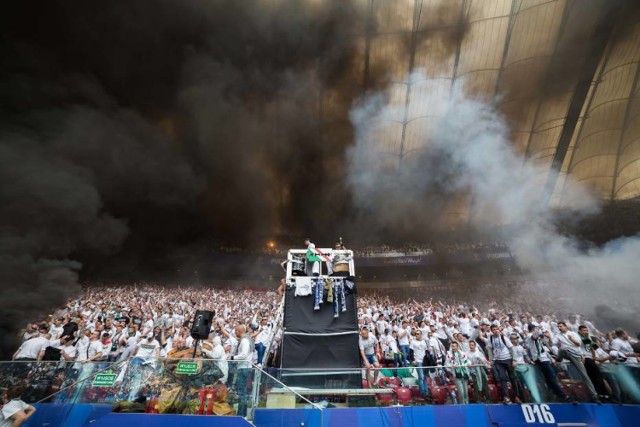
[0,0,384,358]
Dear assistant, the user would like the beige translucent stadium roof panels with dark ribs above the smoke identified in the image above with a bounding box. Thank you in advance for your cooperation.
[348,0,640,206]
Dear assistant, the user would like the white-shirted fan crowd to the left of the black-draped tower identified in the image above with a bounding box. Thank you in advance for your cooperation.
[13,285,279,368]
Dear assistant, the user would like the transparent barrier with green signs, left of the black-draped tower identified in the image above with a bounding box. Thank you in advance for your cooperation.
[0,358,321,427]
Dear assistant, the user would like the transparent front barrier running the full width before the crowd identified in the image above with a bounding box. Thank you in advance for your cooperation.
[0,358,640,426]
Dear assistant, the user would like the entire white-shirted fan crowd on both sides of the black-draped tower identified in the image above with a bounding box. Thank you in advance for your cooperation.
[13,285,640,403]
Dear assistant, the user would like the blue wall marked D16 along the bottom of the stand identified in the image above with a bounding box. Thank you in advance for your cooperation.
[25,404,640,427]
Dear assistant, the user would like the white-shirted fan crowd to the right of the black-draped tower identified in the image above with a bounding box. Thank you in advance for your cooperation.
[358,294,640,403]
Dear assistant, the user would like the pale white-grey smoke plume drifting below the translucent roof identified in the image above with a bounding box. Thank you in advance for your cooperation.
[348,72,640,324]
